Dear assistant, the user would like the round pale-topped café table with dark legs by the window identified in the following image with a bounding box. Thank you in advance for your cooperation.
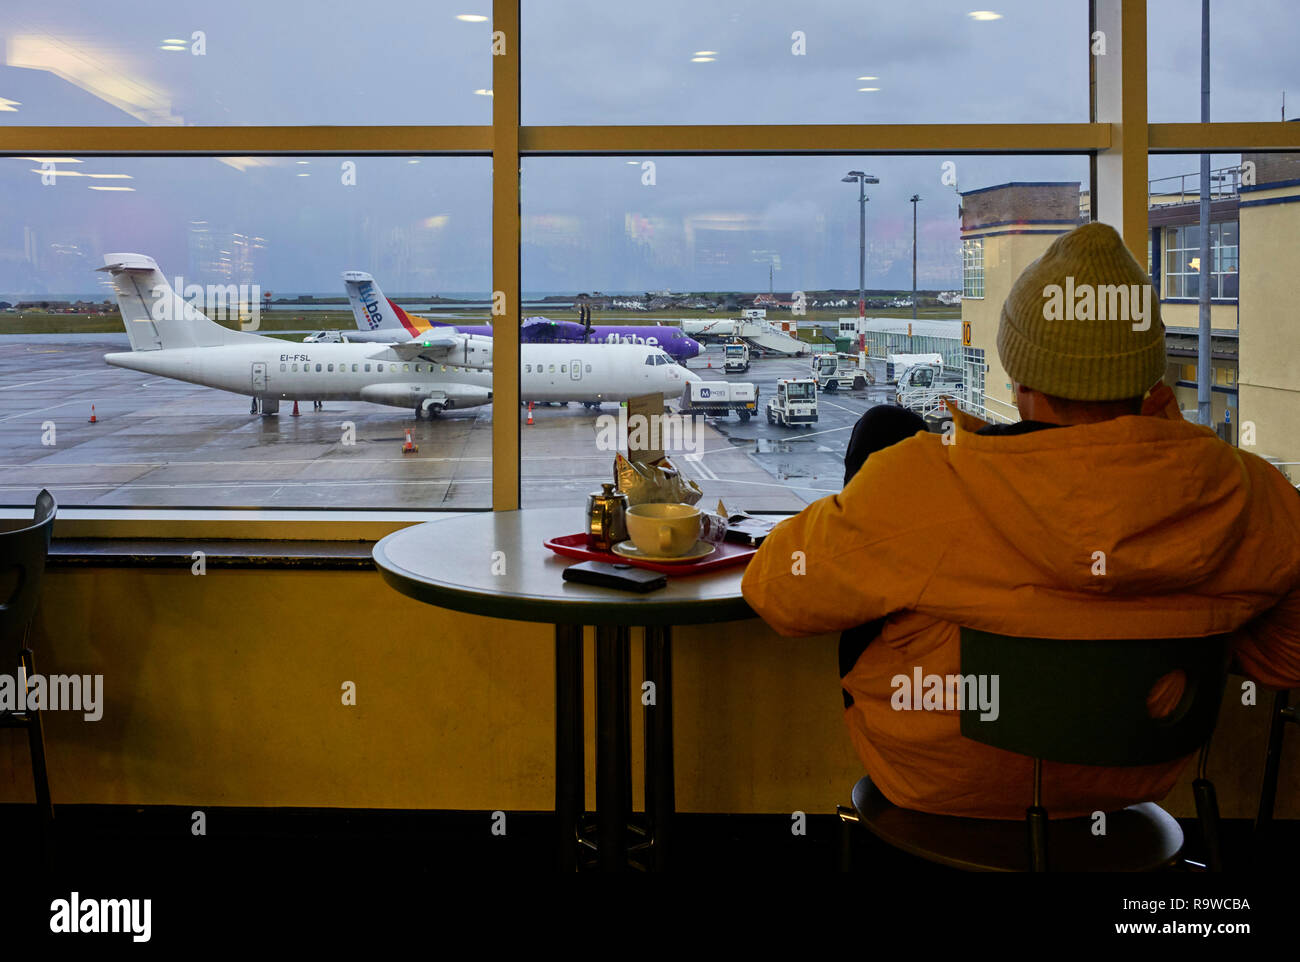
[373,507,754,870]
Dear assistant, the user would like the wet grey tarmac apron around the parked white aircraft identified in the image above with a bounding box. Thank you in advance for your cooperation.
[0,334,887,511]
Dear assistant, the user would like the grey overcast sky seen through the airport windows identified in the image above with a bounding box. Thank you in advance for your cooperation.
[0,0,1300,296]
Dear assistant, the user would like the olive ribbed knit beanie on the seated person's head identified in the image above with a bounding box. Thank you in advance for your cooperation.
[997,224,1166,400]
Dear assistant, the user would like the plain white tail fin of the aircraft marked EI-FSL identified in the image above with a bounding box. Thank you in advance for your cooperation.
[99,254,257,351]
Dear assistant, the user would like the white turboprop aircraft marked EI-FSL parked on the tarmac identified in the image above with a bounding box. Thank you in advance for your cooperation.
[100,254,699,417]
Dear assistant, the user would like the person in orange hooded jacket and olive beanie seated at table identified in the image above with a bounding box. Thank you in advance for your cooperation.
[744,224,1300,819]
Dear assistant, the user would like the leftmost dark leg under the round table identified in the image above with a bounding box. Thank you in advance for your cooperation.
[555,624,586,872]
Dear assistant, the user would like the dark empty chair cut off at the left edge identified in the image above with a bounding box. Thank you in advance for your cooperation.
[0,490,59,840]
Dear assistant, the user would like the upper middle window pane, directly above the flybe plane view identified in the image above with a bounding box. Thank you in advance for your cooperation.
[521,0,1088,126]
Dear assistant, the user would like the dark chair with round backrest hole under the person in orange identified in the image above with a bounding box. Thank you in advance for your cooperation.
[837,628,1229,872]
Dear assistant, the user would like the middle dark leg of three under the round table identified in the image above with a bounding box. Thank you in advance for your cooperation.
[595,625,632,871]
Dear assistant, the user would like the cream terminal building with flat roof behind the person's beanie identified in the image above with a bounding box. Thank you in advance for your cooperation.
[961,161,1300,481]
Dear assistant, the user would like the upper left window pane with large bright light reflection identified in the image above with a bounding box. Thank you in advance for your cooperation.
[0,0,491,126]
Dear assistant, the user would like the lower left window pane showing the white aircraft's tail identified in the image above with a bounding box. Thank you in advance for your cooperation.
[0,154,491,512]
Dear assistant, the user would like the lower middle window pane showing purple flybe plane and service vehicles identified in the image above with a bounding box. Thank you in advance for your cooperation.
[521,155,1089,511]
